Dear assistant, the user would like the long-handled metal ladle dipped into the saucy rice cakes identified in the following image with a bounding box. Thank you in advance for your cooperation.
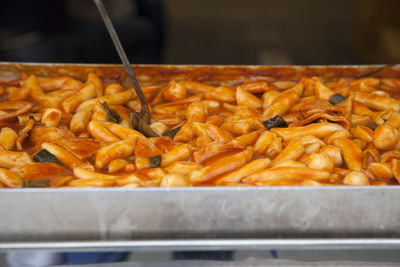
[93,0,161,137]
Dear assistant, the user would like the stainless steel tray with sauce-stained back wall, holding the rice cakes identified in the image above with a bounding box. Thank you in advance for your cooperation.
[0,63,400,250]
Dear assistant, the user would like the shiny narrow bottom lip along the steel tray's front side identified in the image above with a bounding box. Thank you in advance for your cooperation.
[0,238,400,252]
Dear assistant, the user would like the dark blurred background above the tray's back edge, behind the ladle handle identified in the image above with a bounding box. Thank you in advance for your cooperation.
[0,0,400,65]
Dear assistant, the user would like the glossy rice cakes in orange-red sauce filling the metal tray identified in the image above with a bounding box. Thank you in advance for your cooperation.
[0,73,400,187]
